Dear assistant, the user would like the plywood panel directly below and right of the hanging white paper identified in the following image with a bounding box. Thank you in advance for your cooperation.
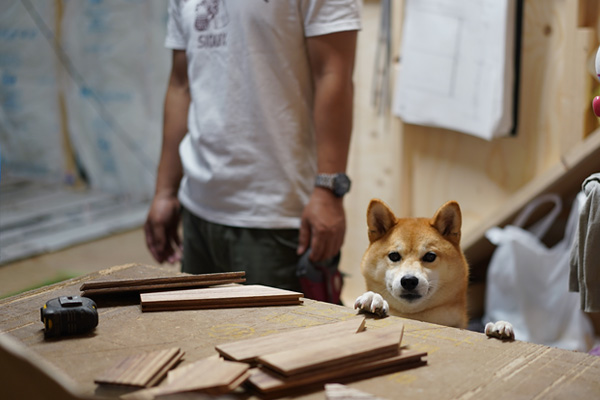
[403,0,595,231]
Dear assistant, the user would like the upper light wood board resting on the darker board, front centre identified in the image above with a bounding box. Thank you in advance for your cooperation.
[258,324,404,376]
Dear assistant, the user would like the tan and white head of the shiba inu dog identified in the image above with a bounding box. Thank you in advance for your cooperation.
[361,199,468,314]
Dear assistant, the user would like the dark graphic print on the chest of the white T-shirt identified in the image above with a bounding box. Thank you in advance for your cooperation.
[194,0,229,49]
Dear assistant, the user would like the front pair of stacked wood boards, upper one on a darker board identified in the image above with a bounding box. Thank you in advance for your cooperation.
[248,325,427,396]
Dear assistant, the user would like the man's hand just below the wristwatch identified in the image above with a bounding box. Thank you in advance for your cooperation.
[298,187,346,262]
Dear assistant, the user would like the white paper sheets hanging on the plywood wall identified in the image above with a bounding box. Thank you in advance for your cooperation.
[393,0,516,140]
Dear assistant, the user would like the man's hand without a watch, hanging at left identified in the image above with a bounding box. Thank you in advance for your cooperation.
[144,195,181,264]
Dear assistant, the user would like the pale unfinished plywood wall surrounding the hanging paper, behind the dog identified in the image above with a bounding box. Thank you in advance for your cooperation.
[342,0,600,303]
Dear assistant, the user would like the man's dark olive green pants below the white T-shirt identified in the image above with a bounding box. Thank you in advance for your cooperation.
[181,208,301,291]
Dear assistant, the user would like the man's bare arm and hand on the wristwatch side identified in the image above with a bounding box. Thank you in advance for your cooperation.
[298,31,357,261]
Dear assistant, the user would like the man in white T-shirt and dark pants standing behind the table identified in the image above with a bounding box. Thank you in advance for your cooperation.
[145,0,360,290]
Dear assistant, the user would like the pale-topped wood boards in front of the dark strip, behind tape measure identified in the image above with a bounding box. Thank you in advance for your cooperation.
[140,285,303,311]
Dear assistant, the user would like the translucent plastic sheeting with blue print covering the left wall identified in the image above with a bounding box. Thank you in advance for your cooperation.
[0,0,171,197]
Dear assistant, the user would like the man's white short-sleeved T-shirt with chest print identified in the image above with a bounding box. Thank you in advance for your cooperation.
[165,0,360,228]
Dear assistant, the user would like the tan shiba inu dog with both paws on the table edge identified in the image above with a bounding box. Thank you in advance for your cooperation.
[354,199,514,339]
